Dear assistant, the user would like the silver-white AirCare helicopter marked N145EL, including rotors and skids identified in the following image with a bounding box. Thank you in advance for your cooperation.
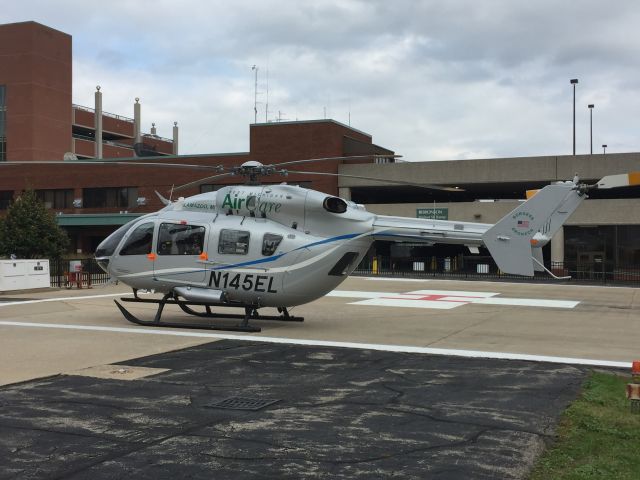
[82,155,640,332]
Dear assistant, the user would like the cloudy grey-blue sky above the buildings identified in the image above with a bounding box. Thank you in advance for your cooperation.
[5,0,640,161]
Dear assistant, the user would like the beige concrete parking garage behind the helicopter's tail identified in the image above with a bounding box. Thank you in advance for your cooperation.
[339,153,640,276]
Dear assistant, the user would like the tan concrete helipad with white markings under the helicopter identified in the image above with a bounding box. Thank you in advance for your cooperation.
[0,278,640,384]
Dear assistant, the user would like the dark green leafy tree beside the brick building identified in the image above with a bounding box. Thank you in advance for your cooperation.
[0,190,69,259]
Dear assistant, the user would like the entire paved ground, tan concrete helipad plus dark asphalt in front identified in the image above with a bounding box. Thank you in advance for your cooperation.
[0,278,640,479]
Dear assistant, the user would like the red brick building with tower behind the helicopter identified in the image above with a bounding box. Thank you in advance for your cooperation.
[0,22,393,254]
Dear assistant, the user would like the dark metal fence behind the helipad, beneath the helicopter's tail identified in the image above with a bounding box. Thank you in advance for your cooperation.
[352,256,640,286]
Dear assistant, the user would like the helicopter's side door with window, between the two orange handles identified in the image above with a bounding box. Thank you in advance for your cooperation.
[153,221,207,286]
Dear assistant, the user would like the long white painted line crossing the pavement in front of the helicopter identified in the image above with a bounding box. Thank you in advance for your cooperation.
[0,320,631,368]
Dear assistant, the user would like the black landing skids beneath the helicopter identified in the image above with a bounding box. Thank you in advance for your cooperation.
[114,293,304,332]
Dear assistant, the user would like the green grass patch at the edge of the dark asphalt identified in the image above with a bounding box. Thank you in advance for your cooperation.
[530,372,640,480]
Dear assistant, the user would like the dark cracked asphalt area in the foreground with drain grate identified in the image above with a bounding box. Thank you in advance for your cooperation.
[0,340,587,479]
